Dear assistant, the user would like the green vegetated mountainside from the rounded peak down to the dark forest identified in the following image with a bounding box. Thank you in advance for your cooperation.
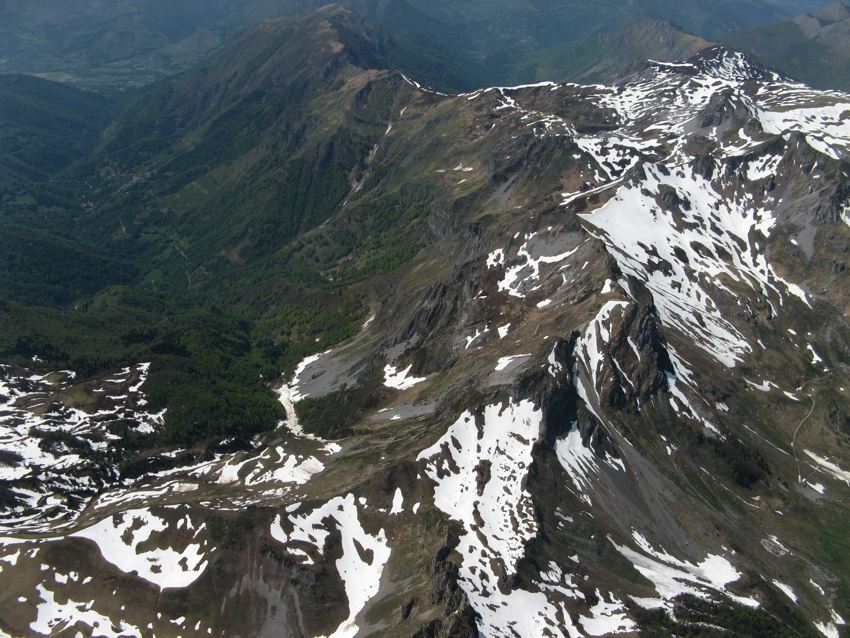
[0,7,444,452]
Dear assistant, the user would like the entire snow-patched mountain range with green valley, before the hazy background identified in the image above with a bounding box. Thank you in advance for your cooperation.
[0,5,850,638]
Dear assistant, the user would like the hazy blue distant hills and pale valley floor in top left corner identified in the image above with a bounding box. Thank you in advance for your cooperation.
[0,0,264,85]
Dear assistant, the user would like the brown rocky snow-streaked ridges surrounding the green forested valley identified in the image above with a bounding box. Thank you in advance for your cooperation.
[0,9,850,638]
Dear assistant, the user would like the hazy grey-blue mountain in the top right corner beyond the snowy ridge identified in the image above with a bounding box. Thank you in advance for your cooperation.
[720,2,850,91]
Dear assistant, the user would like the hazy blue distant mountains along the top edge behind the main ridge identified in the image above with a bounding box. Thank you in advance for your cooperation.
[0,0,836,91]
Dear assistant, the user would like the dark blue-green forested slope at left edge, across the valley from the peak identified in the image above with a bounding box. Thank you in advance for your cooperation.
[0,75,135,307]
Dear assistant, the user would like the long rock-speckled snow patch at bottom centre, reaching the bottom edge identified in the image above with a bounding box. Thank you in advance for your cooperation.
[418,401,581,638]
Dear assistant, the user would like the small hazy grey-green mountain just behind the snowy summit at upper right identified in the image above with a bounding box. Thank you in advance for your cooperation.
[524,20,713,84]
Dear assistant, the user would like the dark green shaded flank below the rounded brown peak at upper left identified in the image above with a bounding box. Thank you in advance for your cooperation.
[65,8,403,304]
